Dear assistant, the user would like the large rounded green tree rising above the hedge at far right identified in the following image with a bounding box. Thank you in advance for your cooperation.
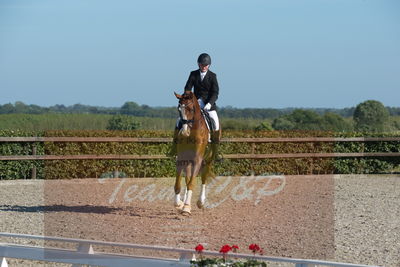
[353,100,389,132]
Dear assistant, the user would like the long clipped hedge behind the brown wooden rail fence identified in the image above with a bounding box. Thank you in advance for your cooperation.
[0,130,400,179]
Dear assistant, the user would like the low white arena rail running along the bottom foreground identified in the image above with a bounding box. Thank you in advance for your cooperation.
[0,232,378,267]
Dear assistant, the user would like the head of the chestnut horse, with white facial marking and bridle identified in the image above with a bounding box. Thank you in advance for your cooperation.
[174,92,200,136]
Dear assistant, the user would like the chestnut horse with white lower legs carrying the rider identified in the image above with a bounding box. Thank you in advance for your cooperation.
[174,92,215,215]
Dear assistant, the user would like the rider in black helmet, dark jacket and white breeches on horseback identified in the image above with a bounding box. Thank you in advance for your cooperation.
[170,53,220,158]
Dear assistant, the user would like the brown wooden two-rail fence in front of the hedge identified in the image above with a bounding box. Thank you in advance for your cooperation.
[0,137,400,161]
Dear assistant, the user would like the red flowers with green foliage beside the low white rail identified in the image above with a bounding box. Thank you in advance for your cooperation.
[190,244,267,267]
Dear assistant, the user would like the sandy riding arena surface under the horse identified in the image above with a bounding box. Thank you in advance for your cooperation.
[0,175,400,266]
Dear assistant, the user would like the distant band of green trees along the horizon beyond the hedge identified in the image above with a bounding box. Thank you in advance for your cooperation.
[0,100,400,132]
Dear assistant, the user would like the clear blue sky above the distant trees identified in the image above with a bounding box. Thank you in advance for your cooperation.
[0,0,400,108]
